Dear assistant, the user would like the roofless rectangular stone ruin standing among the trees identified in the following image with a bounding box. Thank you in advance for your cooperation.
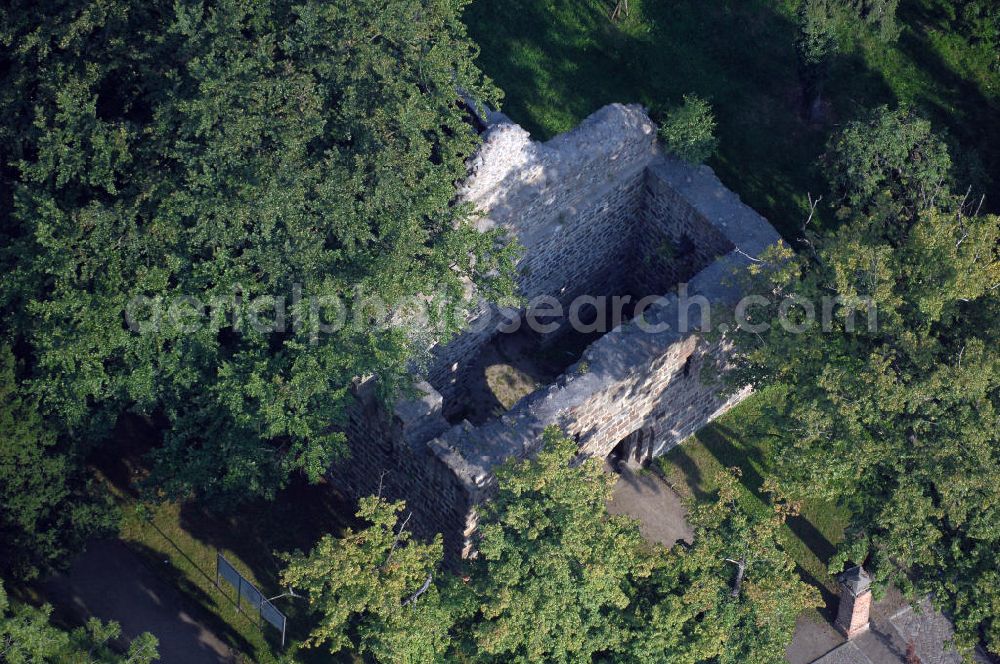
[330,104,779,562]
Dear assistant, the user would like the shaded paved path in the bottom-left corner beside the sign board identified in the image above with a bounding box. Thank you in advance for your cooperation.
[46,540,232,664]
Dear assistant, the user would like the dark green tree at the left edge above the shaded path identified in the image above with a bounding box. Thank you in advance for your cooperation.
[0,346,114,580]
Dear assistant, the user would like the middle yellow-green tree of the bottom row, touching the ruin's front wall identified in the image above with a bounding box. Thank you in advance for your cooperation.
[462,428,653,662]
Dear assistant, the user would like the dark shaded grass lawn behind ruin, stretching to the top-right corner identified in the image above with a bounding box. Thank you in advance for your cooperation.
[466,0,1000,240]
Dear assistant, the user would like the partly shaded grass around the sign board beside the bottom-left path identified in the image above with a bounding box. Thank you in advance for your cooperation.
[88,418,353,664]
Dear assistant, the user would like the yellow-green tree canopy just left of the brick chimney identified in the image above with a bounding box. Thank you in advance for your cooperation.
[620,471,822,664]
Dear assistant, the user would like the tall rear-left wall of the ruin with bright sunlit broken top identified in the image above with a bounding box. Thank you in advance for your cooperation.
[425,104,657,400]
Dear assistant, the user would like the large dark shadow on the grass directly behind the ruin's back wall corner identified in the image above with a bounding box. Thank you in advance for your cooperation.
[466,0,904,241]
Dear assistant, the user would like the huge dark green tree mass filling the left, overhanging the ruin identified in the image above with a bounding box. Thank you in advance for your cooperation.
[0,0,510,495]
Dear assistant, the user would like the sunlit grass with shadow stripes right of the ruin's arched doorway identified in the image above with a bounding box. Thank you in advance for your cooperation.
[658,389,849,607]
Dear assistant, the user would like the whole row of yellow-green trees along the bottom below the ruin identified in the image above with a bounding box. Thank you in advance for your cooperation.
[284,429,819,664]
